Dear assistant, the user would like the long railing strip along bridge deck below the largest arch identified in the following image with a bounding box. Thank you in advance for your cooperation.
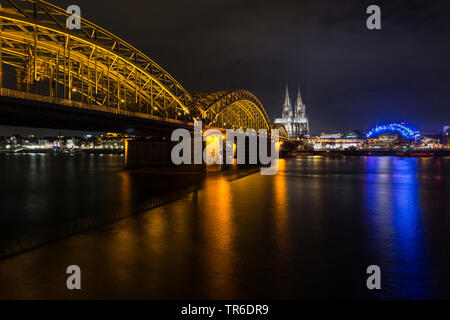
[0,88,194,126]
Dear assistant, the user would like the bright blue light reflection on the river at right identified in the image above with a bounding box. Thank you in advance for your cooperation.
[365,157,432,298]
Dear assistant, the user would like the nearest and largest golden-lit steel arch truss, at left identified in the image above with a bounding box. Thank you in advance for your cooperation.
[0,0,192,120]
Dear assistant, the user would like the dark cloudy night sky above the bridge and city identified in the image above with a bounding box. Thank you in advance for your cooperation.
[0,0,450,134]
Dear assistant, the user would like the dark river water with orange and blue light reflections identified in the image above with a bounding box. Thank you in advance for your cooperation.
[0,154,450,299]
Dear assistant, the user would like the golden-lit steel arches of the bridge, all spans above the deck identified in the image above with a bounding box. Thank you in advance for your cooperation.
[0,0,287,138]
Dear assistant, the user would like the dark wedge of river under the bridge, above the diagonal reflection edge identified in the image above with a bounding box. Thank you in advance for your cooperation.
[0,154,204,259]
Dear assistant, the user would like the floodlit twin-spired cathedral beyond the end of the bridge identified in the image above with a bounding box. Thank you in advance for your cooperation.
[275,86,309,139]
